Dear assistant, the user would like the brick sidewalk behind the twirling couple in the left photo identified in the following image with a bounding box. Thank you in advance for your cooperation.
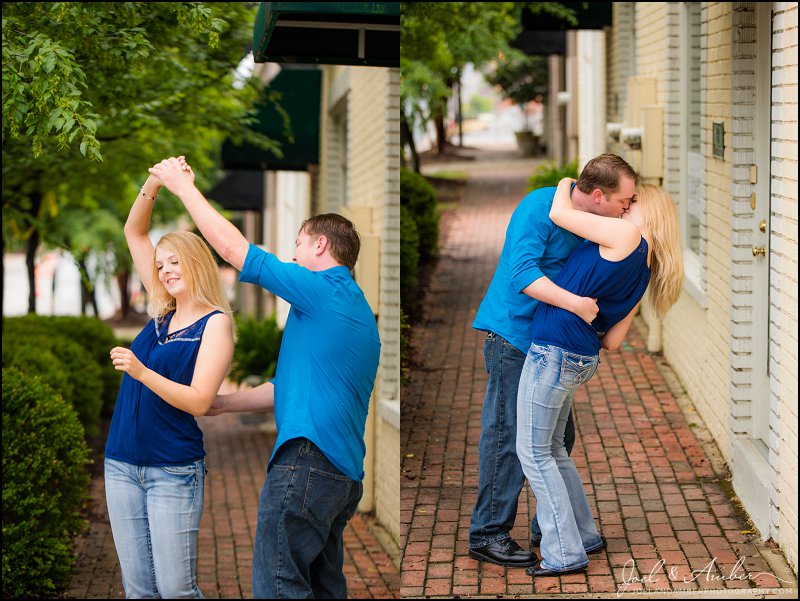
[67,414,400,599]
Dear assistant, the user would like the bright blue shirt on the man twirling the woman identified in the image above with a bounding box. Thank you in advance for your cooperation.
[239,244,381,480]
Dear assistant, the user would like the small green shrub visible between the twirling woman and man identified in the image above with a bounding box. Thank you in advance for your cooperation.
[229,315,283,384]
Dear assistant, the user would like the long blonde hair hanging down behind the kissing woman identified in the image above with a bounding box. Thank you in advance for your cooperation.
[636,184,683,317]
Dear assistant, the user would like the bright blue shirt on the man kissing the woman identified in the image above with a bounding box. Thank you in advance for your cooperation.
[472,187,583,354]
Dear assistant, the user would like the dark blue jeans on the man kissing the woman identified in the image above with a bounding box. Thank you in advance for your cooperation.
[469,332,575,549]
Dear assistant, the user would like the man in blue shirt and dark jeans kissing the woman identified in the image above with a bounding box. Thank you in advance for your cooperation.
[469,154,637,567]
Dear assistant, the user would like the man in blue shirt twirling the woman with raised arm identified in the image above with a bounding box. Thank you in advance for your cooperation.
[151,158,380,599]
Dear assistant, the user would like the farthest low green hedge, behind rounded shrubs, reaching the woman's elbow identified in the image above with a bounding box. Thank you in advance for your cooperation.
[3,314,121,415]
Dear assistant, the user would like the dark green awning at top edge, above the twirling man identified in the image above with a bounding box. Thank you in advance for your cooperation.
[253,2,400,67]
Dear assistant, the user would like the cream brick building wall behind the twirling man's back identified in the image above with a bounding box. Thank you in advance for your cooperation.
[312,66,400,542]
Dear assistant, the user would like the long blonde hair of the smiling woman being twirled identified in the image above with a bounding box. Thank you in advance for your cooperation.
[148,232,233,332]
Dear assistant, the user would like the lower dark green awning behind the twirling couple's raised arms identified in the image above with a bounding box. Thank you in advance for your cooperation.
[222,67,322,171]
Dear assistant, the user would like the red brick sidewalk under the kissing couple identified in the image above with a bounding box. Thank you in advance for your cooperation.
[400,154,797,598]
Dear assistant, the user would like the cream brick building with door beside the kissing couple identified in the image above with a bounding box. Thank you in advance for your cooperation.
[566,2,798,572]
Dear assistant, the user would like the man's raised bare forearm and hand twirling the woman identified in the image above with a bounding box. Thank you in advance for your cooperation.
[149,157,250,271]
